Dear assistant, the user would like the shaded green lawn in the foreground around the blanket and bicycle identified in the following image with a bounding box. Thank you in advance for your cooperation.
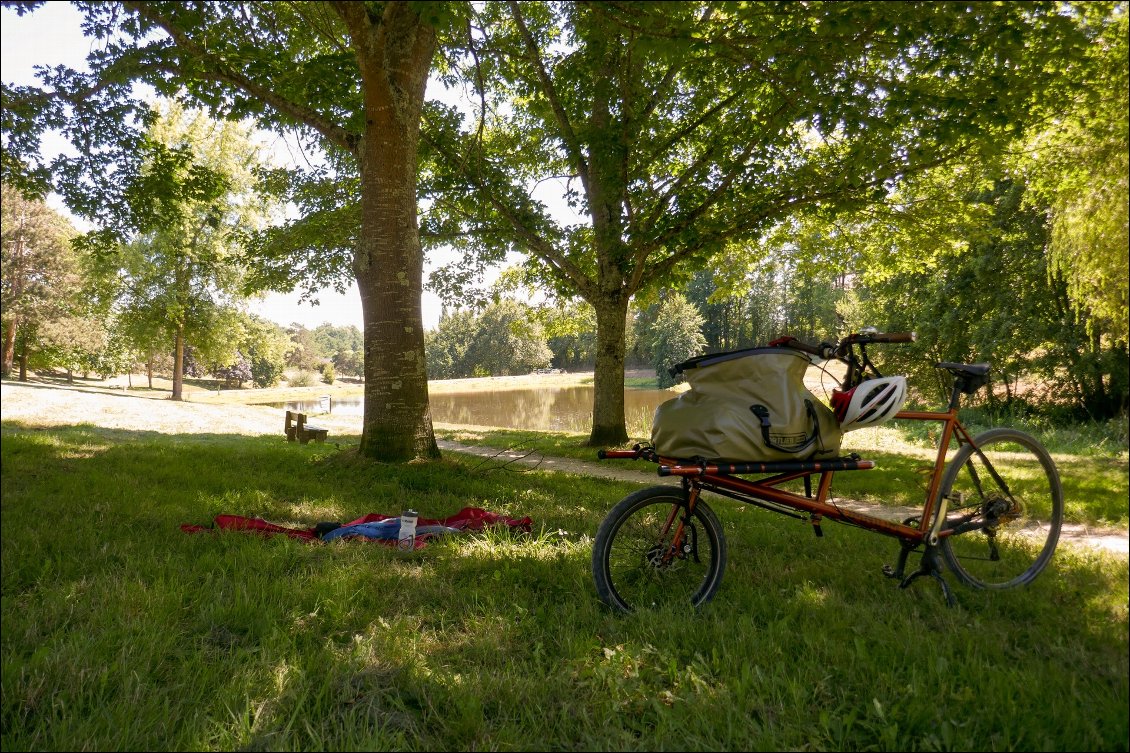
[0,424,1130,751]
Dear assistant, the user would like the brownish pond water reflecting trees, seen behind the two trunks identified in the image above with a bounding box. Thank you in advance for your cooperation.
[272,384,676,436]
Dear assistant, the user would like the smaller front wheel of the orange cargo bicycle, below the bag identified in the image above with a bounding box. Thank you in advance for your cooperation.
[592,486,725,612]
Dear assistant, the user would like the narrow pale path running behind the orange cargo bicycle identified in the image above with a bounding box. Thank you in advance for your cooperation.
[437,440,1130,556]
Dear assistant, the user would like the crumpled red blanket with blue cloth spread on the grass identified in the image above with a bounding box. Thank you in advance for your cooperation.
[181,508,533,549]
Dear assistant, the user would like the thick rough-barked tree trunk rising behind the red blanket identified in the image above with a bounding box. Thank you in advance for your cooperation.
[354,3,440,462]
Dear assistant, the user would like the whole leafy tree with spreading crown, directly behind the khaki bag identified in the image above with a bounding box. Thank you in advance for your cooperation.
[425,1,1102,444]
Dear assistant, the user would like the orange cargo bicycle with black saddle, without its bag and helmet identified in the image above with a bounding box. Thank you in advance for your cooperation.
[592,330,1063,613]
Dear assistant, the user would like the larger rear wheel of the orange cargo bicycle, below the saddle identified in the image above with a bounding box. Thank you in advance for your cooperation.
[940,429,1063,589]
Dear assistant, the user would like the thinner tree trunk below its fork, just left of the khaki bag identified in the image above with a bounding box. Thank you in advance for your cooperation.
[589,296,628,447]
